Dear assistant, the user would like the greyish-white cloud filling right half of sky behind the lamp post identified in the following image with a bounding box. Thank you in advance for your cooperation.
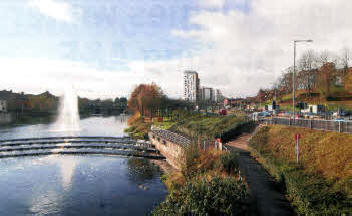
[166,0,352,96]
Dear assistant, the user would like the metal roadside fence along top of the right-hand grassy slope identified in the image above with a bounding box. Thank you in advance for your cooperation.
[259,118,352,133]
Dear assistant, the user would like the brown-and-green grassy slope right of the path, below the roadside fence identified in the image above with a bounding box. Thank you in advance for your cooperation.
[250,126,352,215]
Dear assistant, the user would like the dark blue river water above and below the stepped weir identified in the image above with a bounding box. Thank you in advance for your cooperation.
[0,117,167,215]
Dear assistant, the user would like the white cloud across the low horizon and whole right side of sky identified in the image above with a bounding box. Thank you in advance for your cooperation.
[4,0,352,98]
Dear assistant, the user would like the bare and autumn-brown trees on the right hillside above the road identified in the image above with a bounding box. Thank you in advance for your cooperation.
[257,48,352,101]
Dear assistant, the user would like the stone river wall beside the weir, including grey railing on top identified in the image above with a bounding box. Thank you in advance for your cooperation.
[148,127,191,169]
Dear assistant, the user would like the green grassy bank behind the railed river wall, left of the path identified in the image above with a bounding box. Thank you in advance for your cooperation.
[125,111,254,142]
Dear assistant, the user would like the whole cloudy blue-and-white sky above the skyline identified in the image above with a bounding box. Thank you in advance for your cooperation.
[0,0,352,98]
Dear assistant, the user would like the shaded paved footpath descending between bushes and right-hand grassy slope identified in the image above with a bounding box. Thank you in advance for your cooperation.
[227,134,294,216]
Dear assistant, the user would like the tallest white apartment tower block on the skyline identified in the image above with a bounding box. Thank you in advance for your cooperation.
[184,71,200,103]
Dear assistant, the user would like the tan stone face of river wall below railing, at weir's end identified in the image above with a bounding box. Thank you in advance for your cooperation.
[148,131,185,169]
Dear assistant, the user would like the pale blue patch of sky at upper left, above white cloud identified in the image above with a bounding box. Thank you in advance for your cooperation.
[0,0,250,70]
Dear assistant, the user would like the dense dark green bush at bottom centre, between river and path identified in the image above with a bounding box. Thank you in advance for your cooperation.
[153,177,248,215]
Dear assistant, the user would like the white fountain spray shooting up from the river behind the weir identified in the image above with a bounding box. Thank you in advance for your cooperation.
[54,87,79,131]
